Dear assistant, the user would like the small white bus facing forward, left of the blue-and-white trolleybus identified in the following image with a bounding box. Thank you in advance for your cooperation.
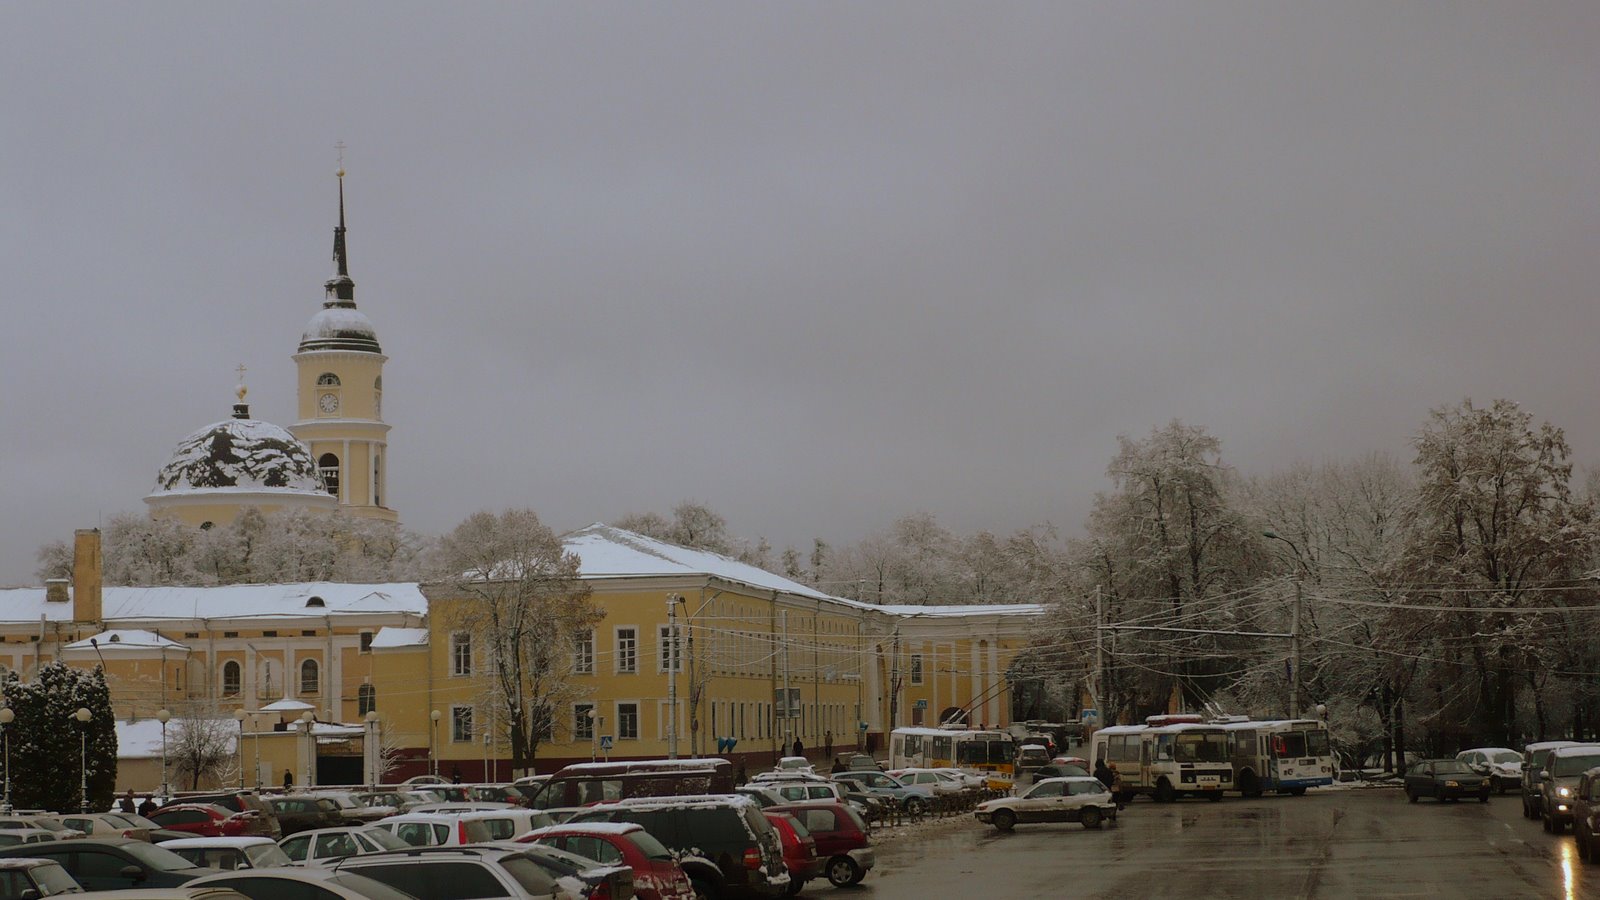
[1090,716,1234,802]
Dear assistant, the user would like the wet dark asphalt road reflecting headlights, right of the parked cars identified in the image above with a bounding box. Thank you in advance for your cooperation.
[803,788,1600,900]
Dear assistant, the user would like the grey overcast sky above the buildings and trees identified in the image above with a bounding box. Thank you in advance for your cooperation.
[0,0,1600,583]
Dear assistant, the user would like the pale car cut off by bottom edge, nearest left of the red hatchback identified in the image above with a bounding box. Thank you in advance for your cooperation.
[331,846,572,900]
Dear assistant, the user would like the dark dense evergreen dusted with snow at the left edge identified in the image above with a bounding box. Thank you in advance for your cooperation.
[3,663,117,812]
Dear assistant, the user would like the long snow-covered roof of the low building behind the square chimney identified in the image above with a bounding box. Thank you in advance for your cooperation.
[0,581,427,621]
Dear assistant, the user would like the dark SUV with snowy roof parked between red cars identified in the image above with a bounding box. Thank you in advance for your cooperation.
[568,794,789,898]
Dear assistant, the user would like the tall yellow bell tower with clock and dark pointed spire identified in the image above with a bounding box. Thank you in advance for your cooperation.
[290,165,400,522]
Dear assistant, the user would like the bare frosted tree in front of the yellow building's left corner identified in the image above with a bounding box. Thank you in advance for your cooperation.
[430,509,602,772]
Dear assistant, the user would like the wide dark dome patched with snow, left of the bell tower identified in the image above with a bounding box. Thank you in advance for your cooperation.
[150,418,333,500]
